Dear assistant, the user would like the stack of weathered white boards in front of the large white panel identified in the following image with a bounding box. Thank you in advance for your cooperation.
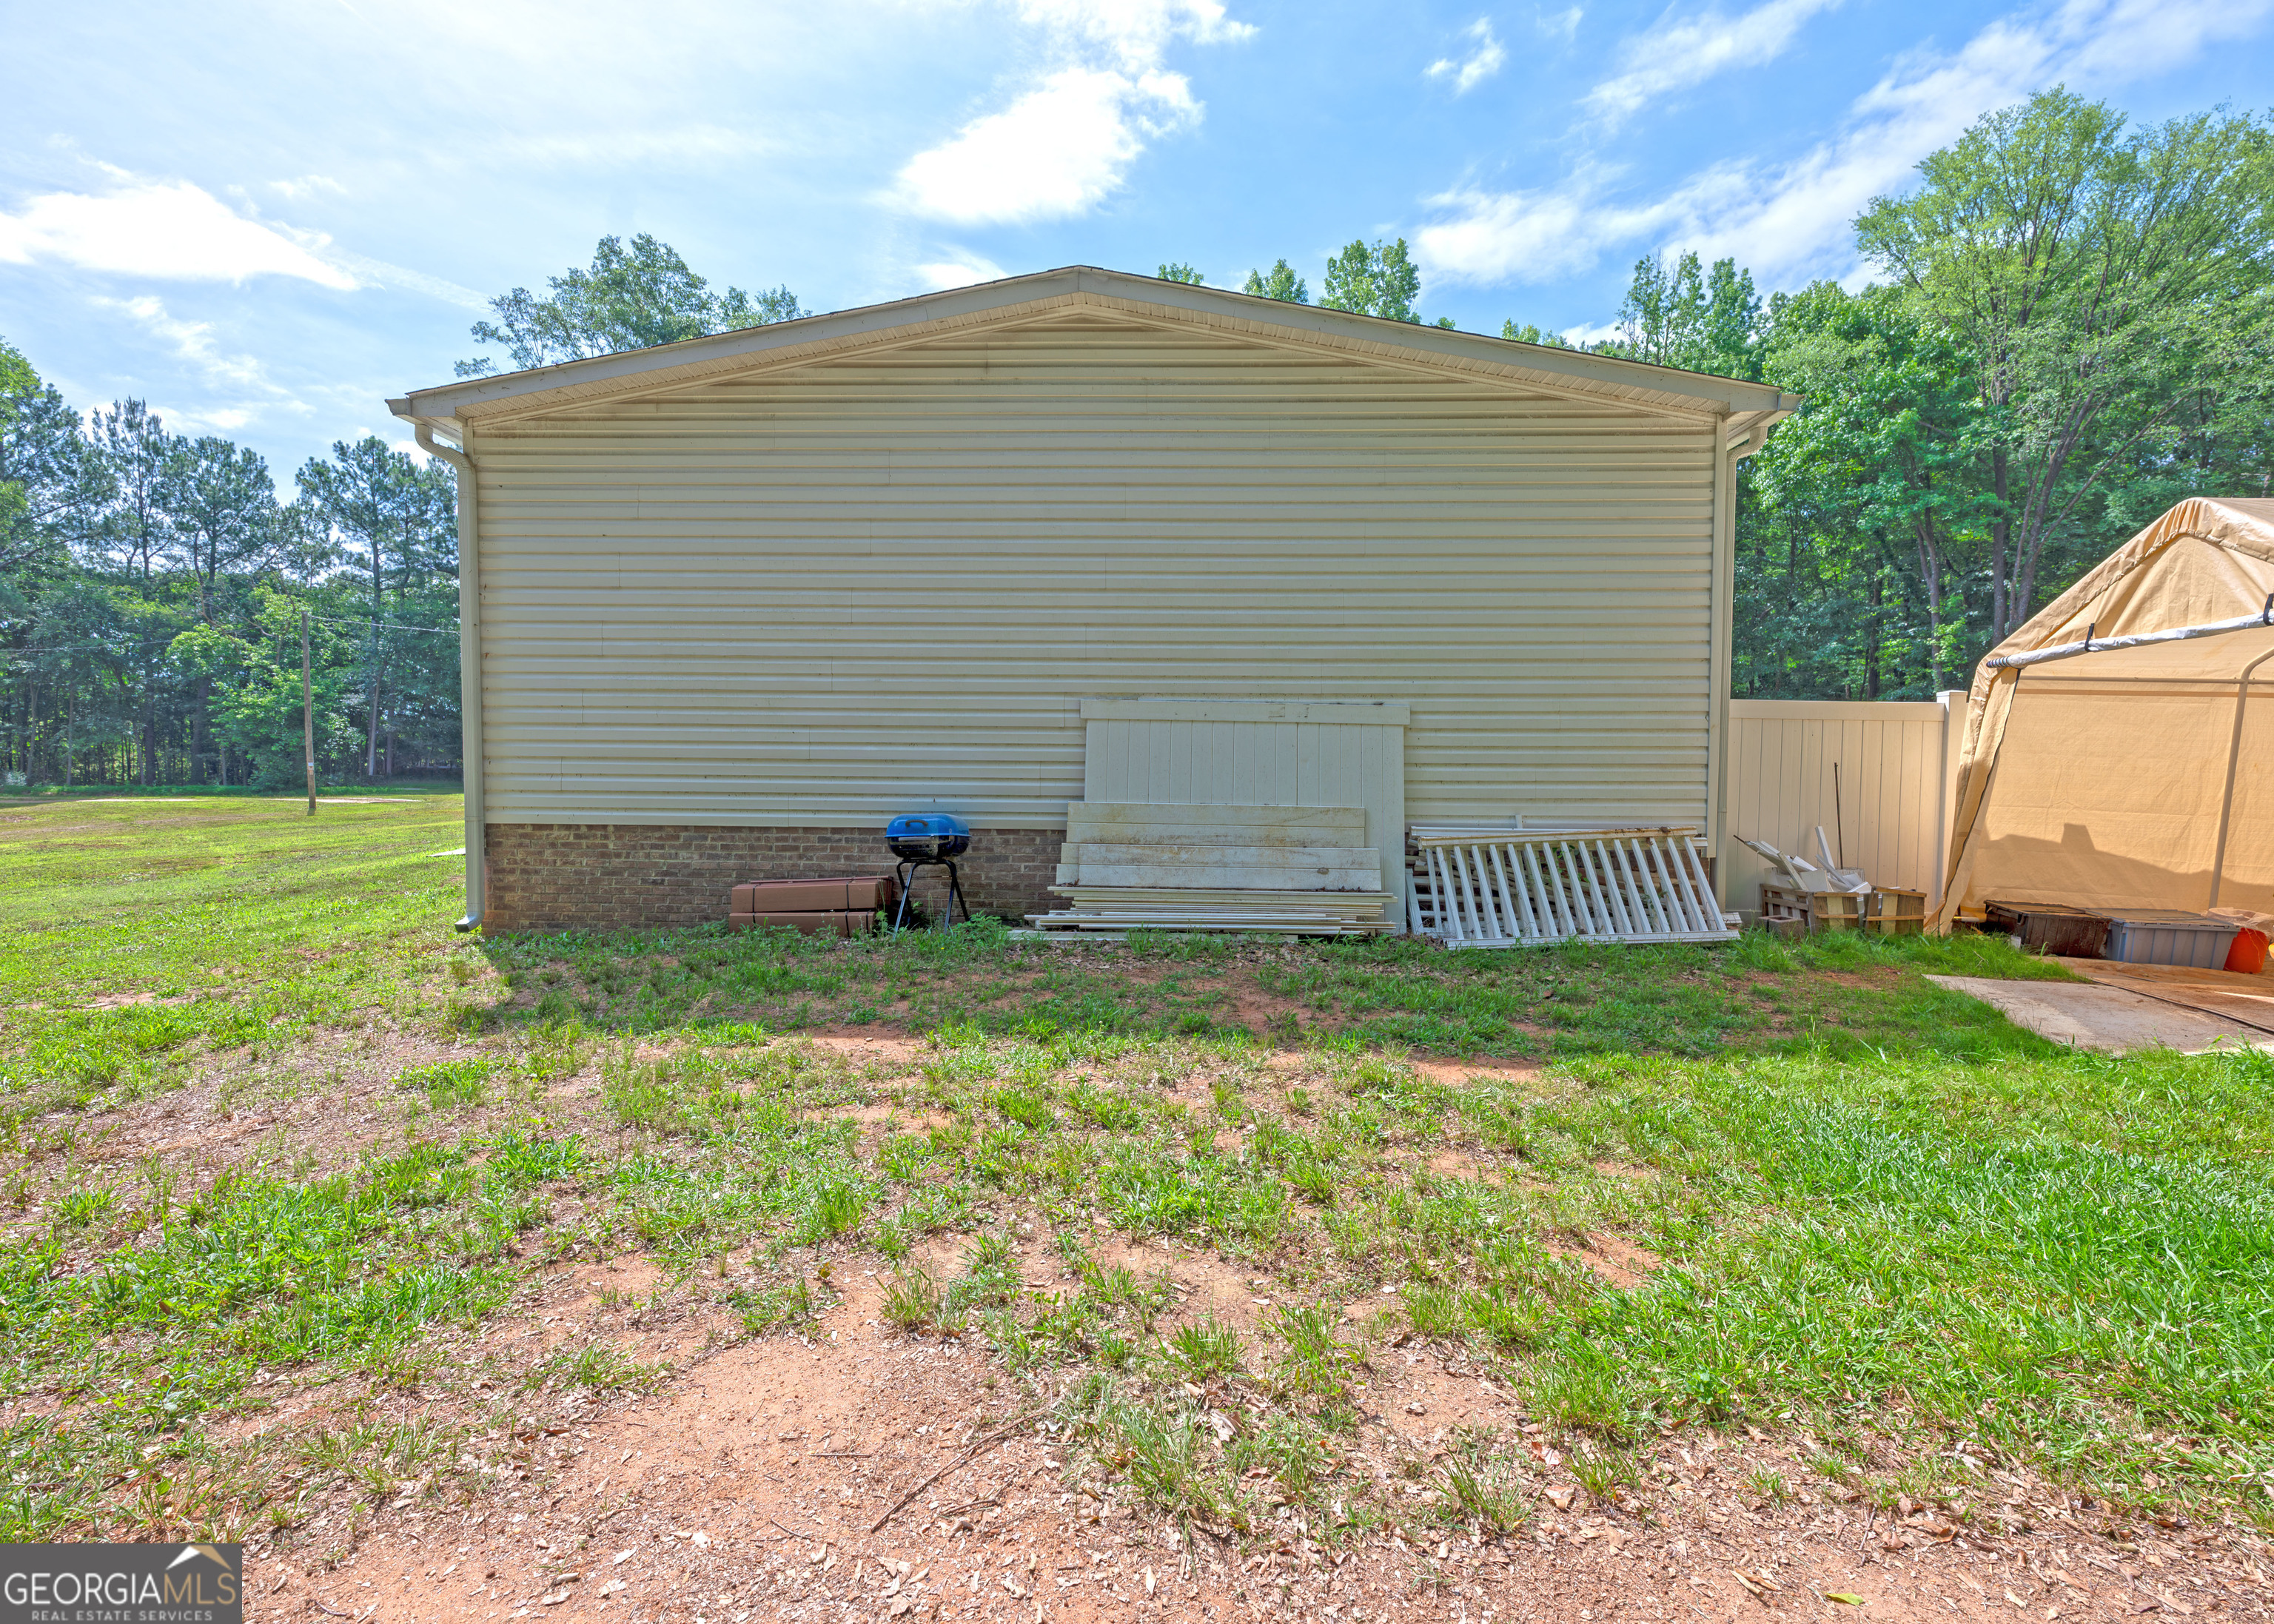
[1033,801,1394,935]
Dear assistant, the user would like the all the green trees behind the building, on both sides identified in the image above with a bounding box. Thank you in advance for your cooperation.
[0,91,2274,787]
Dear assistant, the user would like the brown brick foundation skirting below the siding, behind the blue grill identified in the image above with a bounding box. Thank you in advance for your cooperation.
[482,823,1067,930]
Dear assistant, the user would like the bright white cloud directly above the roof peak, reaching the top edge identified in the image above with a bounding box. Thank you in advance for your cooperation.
[885,0,1255,225]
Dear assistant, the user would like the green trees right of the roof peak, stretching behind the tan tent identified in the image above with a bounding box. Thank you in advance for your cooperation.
[1191,89,2274,698]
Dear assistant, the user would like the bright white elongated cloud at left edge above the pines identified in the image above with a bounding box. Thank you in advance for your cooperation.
[0,170,355,291]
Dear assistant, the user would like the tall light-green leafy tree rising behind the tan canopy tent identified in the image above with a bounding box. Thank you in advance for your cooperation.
[1856,91,2274,639]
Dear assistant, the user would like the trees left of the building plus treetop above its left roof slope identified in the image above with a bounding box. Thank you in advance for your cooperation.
[0,237,805,787]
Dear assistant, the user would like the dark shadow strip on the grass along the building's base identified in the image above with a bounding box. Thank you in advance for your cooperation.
[460,919,2070,1060]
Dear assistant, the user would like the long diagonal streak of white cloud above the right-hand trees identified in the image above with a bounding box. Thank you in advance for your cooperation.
[1415,0,2274,284]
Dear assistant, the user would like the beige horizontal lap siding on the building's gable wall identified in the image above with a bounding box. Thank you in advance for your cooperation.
[473,316,1712,825]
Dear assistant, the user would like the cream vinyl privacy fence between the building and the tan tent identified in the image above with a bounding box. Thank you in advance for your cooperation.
[1714,691,1967,914]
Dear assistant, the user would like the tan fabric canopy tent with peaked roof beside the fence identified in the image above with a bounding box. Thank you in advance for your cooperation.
[1935,498,2274,930]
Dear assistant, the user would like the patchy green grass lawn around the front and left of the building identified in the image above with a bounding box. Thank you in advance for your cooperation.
[0,793,2274,1540]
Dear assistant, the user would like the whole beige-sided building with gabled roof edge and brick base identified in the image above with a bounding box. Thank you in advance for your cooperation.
[389,266,1797,928]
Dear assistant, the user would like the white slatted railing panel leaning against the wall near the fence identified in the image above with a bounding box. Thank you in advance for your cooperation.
[1408,825,1737,948]
